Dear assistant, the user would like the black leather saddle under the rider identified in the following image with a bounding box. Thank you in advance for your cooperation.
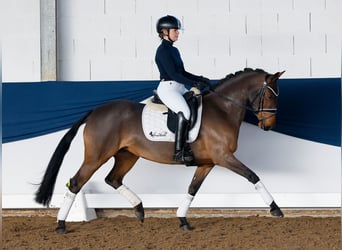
[151,90,199,133]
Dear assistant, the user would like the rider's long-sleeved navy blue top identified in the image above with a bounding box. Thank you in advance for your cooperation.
[155,39,201,86]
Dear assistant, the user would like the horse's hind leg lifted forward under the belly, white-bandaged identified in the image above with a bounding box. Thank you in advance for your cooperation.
[105,150,145,222]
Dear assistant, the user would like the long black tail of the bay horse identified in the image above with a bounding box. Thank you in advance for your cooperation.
[35,111,91,205]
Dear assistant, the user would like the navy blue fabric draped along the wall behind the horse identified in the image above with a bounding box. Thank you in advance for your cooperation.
[2,78,341,146]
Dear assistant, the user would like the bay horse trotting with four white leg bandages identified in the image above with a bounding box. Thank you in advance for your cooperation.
[35,69,284,233]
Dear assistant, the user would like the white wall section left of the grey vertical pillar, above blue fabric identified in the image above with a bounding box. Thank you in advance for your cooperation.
[1,0,40,82]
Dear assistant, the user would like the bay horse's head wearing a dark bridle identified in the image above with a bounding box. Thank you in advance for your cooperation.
[251,71,285,130]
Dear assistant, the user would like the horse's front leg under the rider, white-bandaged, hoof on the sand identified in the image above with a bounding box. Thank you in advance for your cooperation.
[177,165,214,231]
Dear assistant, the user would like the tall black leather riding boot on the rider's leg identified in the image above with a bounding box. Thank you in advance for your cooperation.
[173,112,195,166]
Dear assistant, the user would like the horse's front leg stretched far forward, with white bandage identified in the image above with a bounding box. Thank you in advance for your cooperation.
[218,154,284,217]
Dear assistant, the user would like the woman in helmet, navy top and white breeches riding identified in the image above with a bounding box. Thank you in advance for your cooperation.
[155,15,210,165]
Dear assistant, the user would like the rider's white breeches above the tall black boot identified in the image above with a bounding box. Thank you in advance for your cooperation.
[157,81,190,120]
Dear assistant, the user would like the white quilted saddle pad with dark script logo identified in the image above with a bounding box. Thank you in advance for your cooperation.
[142,98,202,143]
